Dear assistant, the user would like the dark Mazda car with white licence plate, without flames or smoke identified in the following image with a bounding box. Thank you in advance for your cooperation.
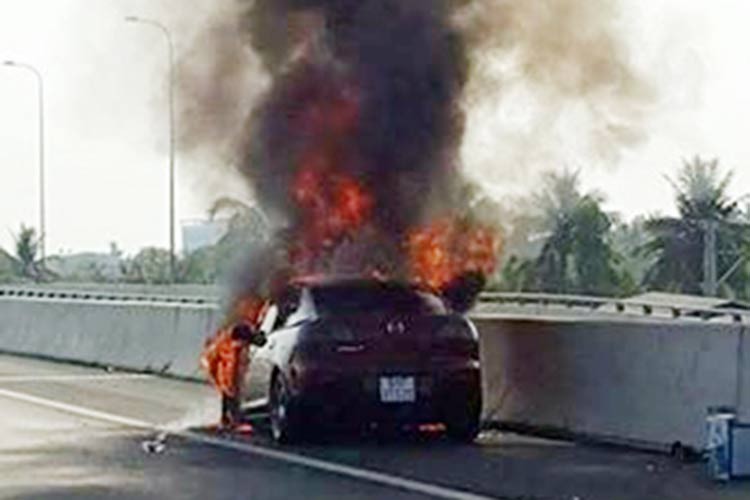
[250,279,482,442]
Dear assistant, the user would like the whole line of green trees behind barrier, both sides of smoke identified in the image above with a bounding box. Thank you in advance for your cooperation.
[0,157,750,299]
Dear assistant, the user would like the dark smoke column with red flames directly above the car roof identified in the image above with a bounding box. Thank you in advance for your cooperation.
[181,0,500,312]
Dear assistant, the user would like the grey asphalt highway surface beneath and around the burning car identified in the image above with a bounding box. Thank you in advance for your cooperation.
[0,355,750,500]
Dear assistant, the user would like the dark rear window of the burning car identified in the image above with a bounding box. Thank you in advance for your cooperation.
[312,283,445,316]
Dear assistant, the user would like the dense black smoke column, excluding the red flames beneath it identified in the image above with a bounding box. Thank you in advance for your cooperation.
[247,0,468,232]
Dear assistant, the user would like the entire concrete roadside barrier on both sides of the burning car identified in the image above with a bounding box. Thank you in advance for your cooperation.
[0,291,750,447]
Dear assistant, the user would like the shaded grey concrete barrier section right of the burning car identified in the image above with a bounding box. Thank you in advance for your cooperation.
[476,318,750,448]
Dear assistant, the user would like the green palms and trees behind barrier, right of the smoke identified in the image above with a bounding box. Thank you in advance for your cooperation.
[494,157,750,299]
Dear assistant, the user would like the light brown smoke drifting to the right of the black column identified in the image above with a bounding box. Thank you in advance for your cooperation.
[461,0,657,183]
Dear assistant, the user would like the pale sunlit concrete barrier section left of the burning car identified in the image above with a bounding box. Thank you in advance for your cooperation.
[0,296,218,377]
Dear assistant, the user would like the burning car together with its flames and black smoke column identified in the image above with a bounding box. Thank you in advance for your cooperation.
[194,0,502,441]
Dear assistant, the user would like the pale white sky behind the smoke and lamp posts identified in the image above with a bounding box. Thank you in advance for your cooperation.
[0,0,750,253]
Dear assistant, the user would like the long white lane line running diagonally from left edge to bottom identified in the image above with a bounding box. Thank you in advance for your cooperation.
[0,389,500,500]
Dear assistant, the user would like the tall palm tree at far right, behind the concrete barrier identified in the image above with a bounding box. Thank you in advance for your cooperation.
[641,156,748,294]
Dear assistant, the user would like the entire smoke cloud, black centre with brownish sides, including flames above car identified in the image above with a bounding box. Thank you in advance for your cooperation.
[183,0,651,310]
